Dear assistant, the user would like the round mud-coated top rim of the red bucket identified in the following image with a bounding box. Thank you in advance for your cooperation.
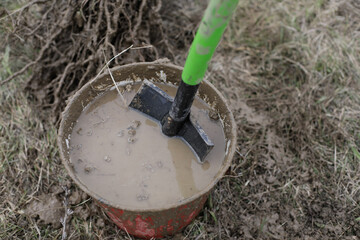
[57,61,237,213]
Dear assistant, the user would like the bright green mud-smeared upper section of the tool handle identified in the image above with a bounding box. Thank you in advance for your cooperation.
[181,0,239,85]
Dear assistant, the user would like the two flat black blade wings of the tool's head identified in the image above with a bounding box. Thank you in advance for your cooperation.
[129,80,214,163]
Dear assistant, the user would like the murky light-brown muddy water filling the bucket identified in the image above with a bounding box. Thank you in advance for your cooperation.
[69,82,225,209]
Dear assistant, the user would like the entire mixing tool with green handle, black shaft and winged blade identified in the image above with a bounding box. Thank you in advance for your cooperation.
[129,0,239,163]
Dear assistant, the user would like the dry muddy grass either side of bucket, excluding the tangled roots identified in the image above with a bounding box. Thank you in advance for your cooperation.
[0,0,360,239]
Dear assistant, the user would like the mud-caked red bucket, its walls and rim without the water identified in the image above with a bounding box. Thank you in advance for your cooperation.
[58,62,236,239]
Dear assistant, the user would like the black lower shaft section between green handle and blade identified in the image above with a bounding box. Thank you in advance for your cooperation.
[162,81,200,136]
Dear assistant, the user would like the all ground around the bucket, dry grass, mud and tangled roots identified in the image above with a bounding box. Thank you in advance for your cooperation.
[0,0,360,239]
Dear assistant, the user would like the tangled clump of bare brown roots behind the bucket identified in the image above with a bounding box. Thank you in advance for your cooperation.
[4,0,200,123]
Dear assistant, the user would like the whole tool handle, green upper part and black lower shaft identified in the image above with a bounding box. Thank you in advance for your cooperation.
[161,0,239,139]
